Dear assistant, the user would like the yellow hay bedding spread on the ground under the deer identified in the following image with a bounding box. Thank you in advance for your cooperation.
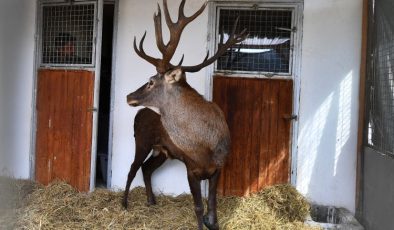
[0,178,318,230]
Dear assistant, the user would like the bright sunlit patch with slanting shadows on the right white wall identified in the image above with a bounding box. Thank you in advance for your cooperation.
[298,71,357,208]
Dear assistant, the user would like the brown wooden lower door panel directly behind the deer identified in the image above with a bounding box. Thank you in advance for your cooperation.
[213,76,293,196]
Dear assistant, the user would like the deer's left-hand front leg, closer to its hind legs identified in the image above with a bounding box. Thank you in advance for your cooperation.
[187,170,204,230]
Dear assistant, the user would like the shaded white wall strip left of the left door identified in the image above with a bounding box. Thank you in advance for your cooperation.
[0,0,36,178]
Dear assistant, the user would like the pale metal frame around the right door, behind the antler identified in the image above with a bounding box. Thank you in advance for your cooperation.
[204,0,304,186]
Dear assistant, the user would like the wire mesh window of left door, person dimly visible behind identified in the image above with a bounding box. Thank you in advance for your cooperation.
[41,3,95,66]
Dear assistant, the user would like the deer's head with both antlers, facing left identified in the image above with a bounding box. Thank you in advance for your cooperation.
[127,0,247,107]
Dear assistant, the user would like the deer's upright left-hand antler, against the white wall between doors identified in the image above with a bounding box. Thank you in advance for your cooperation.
[134,0,207,73]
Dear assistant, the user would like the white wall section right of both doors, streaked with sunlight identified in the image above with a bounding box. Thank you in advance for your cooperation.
[297,0,362,211]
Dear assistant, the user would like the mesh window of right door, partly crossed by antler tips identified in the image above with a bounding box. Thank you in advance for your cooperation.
[216,9,292,74]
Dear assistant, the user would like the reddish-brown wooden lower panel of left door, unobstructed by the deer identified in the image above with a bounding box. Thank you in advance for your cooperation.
[35,69,94,191]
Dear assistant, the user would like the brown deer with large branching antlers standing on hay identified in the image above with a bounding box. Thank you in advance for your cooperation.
[123,0,248,230]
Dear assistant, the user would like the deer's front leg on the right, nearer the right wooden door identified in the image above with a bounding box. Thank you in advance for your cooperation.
[204,169,220,230]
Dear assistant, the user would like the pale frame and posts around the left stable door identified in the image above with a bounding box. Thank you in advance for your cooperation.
[29,0,119,191]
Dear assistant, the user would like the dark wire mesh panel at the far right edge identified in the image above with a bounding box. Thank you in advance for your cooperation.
[367,0,394,156]
